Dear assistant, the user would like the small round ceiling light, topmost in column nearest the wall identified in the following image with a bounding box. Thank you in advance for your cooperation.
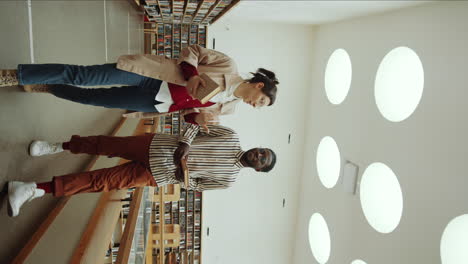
[325,49,352,104]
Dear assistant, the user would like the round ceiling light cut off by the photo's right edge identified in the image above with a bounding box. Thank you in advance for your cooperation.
[440,214,468,264]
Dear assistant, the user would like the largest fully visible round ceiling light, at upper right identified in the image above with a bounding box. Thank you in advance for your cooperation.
[375,47,424,122]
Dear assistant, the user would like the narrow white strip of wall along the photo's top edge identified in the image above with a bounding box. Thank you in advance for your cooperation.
[223,0,427,24]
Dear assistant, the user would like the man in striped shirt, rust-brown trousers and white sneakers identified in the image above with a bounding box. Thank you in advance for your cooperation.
[5,124,276,216]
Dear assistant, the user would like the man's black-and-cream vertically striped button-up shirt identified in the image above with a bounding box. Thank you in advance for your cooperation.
[149,124,244,191]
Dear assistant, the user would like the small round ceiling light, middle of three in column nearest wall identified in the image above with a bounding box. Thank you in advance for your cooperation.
[316,136,341,188]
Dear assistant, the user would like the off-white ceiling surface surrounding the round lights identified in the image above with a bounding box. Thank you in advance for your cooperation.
[294,1,468,264]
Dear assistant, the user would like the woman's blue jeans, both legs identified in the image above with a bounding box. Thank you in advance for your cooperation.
[18,63,162,112]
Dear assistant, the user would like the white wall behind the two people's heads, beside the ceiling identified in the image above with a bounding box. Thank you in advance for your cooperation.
[202,21,313,264]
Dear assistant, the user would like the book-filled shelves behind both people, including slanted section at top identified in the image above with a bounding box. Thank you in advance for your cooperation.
[135,0,239,264]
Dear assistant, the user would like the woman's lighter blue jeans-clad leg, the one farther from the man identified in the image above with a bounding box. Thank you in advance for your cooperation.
[17,63,146,86]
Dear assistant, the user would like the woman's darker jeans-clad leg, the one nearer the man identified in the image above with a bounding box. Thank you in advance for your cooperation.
[48,81,160,112]
